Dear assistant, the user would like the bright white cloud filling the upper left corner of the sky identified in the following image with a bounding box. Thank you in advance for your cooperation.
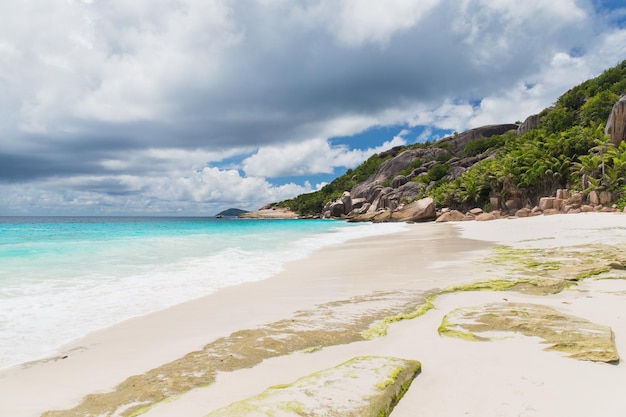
[0,0,241,128]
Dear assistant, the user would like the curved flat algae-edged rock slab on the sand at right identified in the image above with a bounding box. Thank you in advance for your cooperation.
[439,303,619,362]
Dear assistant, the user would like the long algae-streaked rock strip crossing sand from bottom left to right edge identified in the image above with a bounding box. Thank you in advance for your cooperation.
[43,245,626,417]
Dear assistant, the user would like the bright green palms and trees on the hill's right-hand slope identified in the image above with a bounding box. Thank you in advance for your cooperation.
[431,61,626,207]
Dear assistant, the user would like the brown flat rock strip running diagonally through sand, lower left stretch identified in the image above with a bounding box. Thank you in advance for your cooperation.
[42,292,426,417]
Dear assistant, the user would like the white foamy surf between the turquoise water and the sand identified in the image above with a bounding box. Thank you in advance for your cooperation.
[0,219,404,368]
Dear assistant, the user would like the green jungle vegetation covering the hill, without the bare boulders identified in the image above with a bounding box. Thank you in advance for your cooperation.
[277,61,626,215]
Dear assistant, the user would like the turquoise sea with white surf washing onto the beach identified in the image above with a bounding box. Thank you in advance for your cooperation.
[0,217,404,369]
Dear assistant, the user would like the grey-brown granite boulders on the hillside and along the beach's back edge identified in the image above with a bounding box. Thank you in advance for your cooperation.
[241,96,626,222]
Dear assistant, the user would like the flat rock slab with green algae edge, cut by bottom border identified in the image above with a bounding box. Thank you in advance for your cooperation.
[207,356,421,417]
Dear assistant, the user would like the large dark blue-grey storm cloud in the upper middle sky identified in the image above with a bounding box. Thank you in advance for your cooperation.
[160,3,550,146]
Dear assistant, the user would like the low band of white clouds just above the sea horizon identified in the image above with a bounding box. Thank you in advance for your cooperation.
[0,168,313,216]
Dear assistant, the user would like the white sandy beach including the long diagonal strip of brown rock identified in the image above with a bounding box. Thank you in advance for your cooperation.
[0,214,626,417]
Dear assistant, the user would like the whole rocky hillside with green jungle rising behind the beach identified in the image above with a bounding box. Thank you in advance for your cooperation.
[276,61,626,221]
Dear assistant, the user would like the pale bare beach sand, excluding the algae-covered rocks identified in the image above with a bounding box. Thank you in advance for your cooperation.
[0,214,626,417]
